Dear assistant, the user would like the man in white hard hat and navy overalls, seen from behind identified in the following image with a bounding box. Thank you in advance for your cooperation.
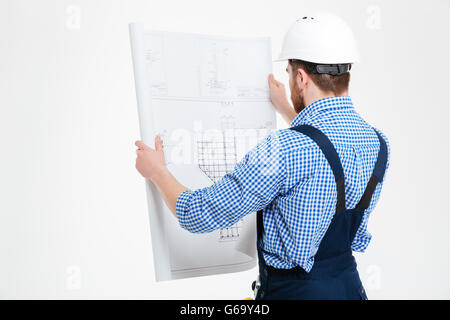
[136,14,389,299]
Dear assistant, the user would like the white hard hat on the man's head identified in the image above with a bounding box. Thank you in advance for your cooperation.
[275,13,359,64]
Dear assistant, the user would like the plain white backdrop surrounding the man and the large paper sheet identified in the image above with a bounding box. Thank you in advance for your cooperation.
[0,0,450,299]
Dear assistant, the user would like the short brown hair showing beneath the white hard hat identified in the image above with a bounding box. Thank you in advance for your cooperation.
[289,59,350,95]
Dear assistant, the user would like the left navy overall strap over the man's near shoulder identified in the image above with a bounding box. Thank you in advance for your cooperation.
[290,125,345,213]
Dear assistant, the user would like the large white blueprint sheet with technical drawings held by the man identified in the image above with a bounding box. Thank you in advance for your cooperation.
[130,24,276,281]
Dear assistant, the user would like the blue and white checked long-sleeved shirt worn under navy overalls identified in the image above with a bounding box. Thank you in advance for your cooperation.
[176,97,390,272]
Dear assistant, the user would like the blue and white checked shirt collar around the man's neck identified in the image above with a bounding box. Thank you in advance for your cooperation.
[291,96,353,127]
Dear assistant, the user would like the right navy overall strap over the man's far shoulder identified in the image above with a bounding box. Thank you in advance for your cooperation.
[355,128,387,211]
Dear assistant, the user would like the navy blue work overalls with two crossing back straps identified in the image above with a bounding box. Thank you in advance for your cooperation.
[255,125,387,300]
